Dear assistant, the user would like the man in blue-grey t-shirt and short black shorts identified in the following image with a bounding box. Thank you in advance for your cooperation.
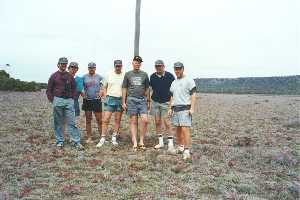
[82,62,103,143]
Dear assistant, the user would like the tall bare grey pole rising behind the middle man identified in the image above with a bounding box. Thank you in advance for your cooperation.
[134,0,141,56]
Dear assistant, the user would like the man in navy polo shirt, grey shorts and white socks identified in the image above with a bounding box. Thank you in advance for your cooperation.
[150,60,175,153]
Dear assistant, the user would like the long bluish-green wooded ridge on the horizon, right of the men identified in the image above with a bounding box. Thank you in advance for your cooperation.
[195,75,300,95]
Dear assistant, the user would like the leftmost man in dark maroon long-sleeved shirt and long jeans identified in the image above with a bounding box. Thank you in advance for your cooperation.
[46,57,84,150]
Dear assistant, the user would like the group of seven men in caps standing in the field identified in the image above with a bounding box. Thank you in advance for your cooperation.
[46,56,196,159]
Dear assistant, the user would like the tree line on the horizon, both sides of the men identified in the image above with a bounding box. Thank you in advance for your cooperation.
[0,70,300,95]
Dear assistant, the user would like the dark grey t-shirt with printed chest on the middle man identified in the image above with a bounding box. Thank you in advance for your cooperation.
[122,70,149,98]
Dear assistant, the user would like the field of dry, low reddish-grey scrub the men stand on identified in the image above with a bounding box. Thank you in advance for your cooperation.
[0,92,300,200]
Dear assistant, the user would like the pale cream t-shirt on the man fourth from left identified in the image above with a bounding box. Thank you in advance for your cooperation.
[103,71,125,97]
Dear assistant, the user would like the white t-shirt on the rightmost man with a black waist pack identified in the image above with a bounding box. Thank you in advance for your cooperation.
[170,75,196,106]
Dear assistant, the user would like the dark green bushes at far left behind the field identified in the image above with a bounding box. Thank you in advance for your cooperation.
[0,70,47,92]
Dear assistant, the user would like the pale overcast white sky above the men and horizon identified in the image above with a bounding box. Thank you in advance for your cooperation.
[0,0,300,82]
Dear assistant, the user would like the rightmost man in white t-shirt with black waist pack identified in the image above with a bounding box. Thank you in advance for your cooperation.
[169,62,196,160]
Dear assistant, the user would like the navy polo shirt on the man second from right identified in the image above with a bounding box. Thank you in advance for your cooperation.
[150,71,175,103]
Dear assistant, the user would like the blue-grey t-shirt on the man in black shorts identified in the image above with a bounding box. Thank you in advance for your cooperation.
[82,74,103,99]
